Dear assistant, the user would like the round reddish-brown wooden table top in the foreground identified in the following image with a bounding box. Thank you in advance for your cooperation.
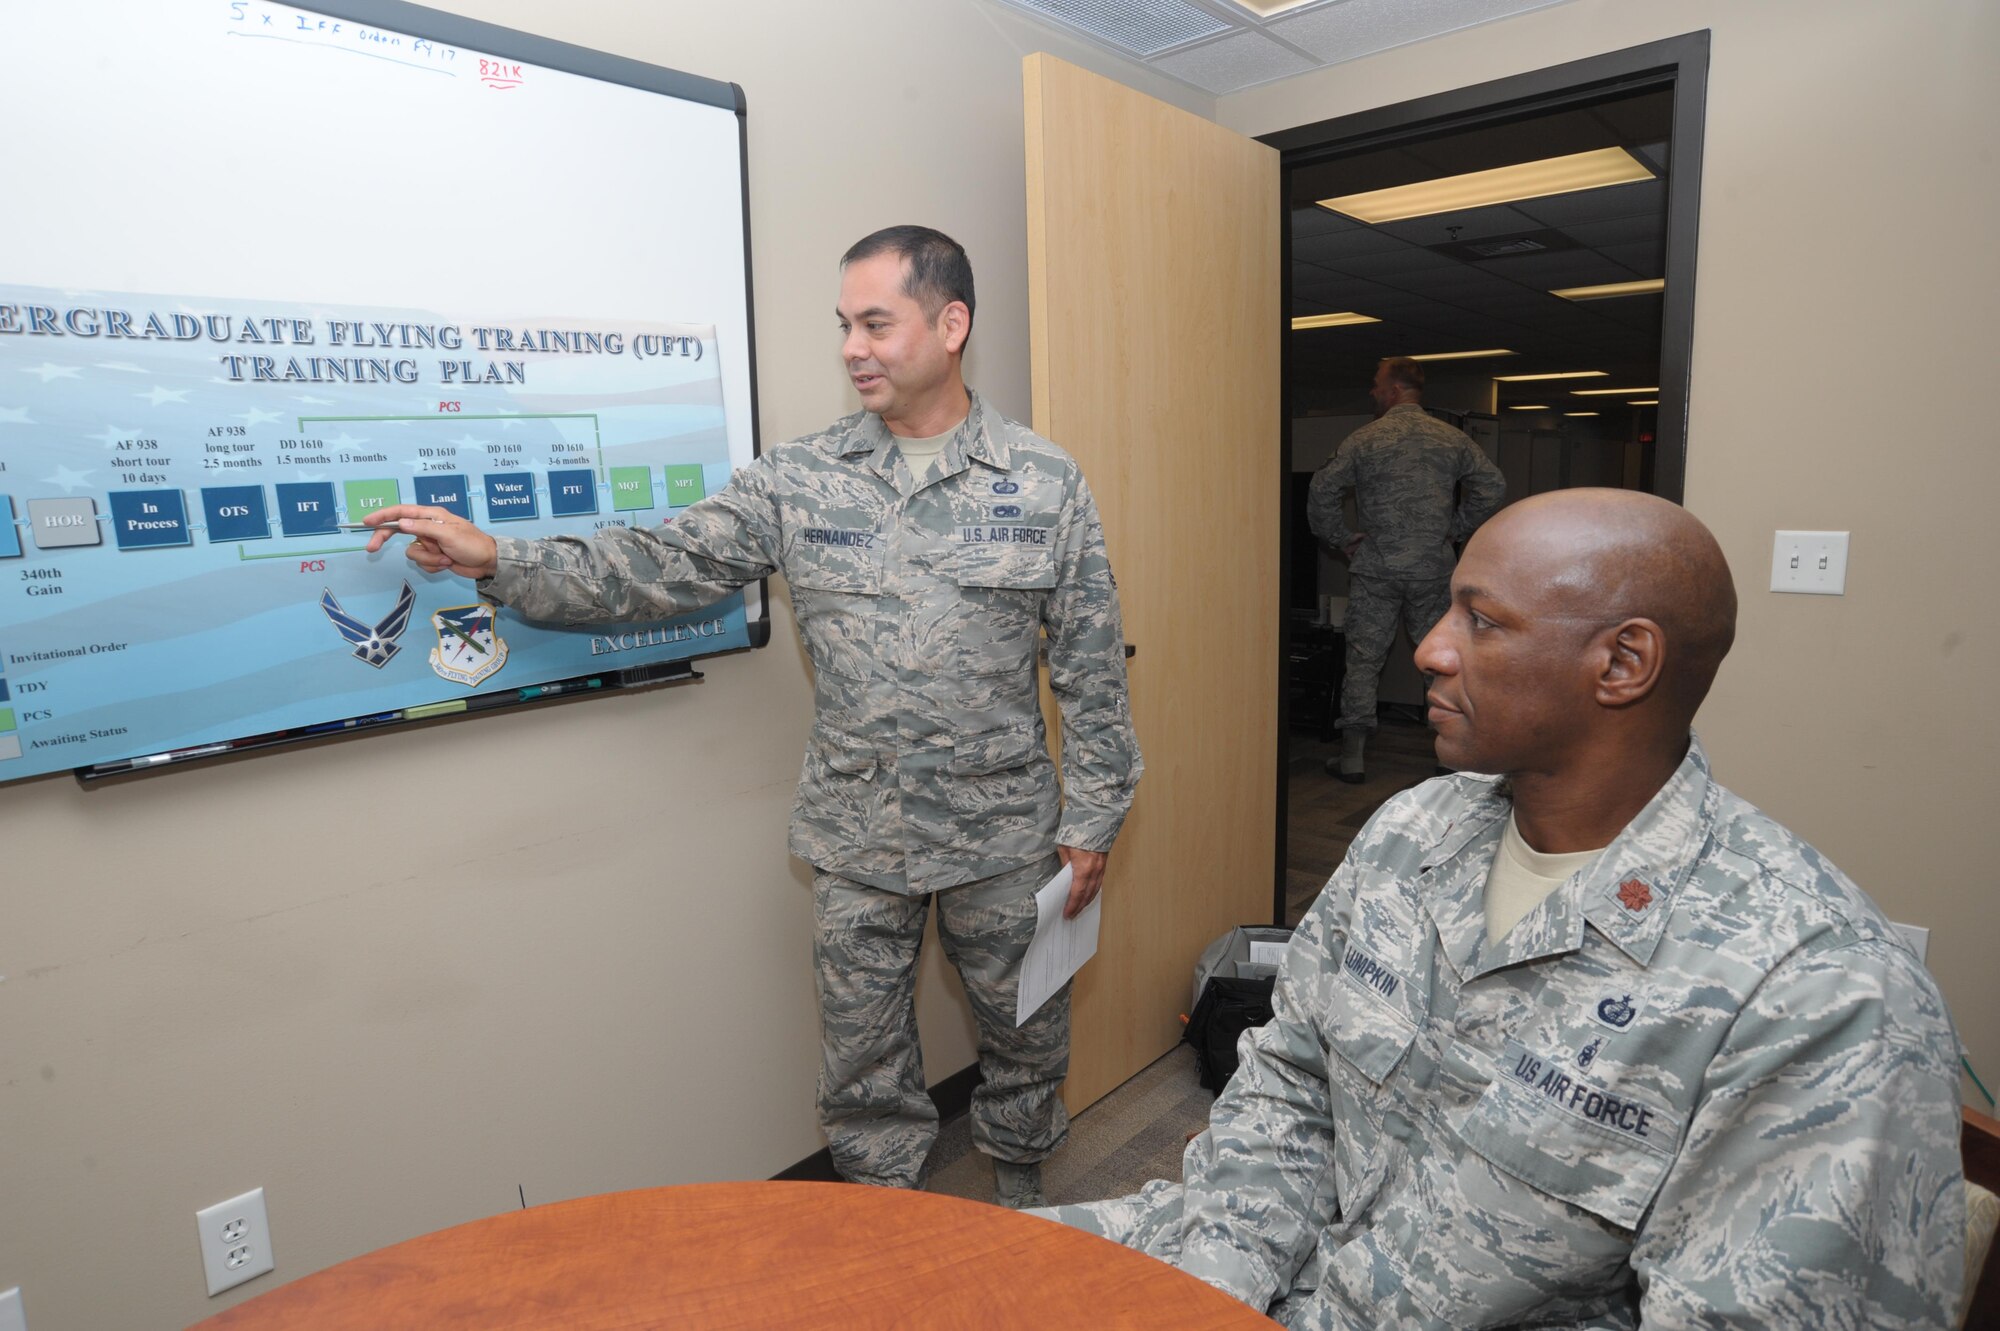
[200,1183,1272,1331]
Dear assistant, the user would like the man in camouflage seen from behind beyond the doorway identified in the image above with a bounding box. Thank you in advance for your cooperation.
[1306,356,1506,783]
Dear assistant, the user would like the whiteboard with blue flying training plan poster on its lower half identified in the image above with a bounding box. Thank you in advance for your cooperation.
[0,0,762,781]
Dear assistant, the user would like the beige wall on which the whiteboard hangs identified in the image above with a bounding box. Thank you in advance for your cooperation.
[0,0,1212,1331]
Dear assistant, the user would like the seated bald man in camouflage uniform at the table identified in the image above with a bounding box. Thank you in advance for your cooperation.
[1054,490,1966,1331]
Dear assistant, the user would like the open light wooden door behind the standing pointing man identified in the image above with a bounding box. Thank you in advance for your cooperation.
[1024,54,1284,1111]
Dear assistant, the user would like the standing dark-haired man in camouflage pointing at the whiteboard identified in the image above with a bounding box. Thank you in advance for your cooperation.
[370,228,1142,1205]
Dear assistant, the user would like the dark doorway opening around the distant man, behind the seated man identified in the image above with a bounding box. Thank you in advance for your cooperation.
[1262,32,1708,923]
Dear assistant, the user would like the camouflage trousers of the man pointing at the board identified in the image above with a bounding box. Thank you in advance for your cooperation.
[812,855,1070,1187]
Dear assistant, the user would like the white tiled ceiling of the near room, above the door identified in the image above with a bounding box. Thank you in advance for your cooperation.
[998,0,1564,96]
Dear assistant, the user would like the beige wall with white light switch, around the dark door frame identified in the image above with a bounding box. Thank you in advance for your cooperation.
[1216,0,2000,1103]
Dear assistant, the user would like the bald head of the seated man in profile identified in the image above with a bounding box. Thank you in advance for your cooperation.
[1418,490,1736,771]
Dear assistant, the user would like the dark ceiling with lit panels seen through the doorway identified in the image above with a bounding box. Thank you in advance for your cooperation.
[1286,90,1674,412]
